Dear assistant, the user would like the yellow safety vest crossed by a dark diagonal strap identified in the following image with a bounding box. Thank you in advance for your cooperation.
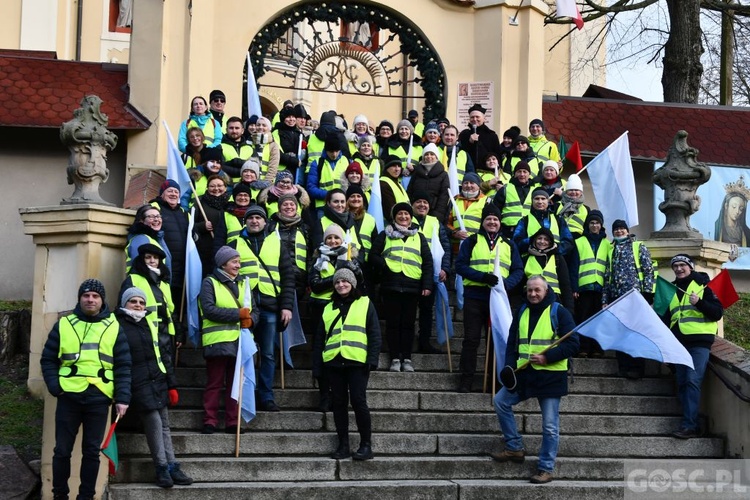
[237,232,281,297]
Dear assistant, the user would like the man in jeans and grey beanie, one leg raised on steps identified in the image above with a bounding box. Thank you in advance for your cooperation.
[490,276,579,484]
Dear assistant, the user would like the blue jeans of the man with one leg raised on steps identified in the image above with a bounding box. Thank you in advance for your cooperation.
[494,387,560,473]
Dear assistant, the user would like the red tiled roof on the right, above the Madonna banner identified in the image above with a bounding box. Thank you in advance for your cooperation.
[542,96,750,166]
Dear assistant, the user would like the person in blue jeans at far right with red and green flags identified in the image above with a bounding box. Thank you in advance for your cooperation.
[663,253,724,439]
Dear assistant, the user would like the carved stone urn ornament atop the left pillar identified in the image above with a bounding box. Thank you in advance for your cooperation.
[60,95,117,206]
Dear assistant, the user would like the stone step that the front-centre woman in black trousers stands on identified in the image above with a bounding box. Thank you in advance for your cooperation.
[113,455,624,483]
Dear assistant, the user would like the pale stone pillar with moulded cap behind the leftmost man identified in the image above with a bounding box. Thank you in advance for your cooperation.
[19,205,134,498]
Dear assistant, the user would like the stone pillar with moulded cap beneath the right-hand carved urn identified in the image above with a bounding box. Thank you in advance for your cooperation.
[644,237,731,337]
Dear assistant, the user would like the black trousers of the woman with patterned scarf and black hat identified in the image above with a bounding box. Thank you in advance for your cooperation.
[382,290,420,360]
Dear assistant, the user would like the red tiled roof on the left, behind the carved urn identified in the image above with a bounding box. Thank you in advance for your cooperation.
[0,50,151,130]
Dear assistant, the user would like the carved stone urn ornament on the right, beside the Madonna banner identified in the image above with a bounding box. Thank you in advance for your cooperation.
[651,130,711,239]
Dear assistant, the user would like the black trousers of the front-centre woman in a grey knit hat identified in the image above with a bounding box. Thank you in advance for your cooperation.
[324,364,372,445]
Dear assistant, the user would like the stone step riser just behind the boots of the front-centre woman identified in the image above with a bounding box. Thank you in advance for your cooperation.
[118,432,724,459]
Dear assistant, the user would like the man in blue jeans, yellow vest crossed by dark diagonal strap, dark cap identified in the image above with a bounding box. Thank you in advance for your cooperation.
[232,205,294,411]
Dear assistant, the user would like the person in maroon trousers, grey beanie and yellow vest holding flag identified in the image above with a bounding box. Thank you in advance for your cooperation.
[199,246,260,434]
